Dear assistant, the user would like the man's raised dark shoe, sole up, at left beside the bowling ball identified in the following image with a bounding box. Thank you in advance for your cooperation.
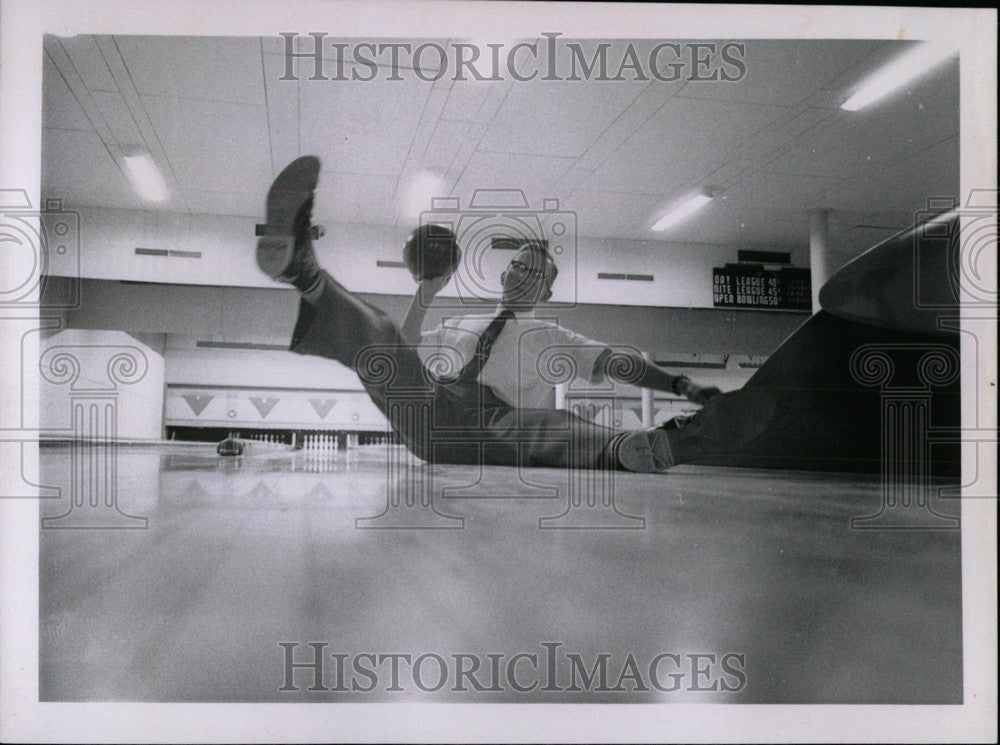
[257,155,320,279]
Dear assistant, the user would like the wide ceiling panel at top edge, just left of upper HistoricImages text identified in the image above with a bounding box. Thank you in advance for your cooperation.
[114,36,264,105]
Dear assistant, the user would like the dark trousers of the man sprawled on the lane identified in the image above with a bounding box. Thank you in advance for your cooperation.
[291,273,616,468]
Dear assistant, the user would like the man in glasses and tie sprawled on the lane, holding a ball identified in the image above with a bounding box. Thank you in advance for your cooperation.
[250,156,761,472]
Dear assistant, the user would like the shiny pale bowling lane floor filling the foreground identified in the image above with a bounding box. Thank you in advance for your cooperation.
[40,444,962,703]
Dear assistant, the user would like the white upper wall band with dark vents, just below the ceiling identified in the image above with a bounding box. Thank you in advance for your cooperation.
[50,207,808,308]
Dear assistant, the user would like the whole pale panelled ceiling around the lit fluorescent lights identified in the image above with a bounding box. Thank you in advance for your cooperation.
[37,36,959,258]
